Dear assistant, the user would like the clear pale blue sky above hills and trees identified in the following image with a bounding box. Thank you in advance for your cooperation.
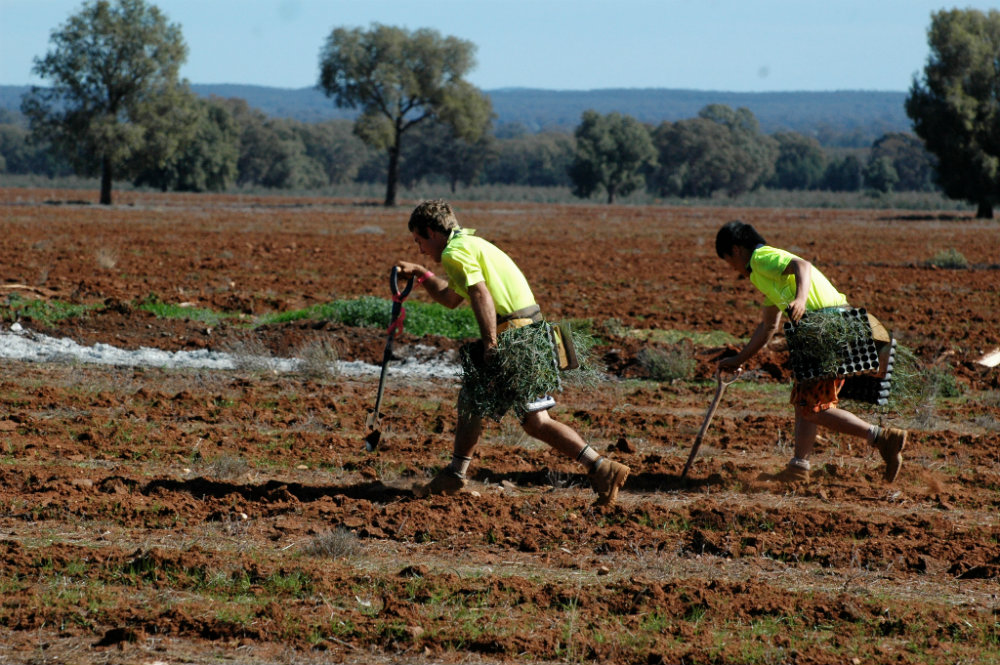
[0,0,996,92]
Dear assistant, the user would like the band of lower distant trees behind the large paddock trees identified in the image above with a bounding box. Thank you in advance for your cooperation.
[0,98,936,202]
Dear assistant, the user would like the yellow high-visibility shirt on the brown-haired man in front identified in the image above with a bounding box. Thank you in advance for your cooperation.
[441,229,535,316]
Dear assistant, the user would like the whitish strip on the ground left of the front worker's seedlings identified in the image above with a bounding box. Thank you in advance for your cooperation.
[0,323,461,379]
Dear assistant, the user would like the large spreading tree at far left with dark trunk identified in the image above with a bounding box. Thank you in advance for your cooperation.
[21,0,197,204]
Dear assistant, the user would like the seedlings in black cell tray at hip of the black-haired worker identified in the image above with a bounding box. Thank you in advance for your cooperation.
[785,307,878,382]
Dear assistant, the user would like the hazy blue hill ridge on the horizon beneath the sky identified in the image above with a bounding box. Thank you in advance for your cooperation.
[0,84,911,137]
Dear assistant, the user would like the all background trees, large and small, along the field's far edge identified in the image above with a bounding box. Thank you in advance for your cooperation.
[0,0,1000,217]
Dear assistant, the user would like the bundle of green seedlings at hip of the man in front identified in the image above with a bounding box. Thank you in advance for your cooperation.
[461,322,600,422]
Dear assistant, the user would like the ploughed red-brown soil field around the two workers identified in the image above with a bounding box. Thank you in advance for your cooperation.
[0,188,1000,665]
